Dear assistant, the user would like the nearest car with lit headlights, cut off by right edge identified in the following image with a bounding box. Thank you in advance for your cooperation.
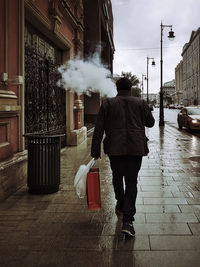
[177,106,200,131]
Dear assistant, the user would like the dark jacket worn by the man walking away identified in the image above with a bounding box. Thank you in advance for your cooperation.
[91,91,155,158]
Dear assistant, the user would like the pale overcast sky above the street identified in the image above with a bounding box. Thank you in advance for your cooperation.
[111,0,200,93]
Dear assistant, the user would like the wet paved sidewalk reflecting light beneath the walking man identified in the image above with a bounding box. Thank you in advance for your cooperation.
[0,120,200,267]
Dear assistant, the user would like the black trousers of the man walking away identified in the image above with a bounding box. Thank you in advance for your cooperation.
[109,155,142,223]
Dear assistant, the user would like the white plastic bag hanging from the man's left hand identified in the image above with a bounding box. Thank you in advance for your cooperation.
[74,159,95,198]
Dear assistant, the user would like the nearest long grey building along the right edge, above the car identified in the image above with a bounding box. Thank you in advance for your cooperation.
[182,28,200,106]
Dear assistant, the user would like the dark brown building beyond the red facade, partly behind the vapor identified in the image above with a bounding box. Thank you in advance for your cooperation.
[83,0,115,123]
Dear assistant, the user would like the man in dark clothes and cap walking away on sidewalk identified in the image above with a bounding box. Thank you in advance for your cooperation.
[91,78,155,239]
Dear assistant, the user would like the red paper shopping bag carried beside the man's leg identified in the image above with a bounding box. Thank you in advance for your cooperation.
[87,168,101,210]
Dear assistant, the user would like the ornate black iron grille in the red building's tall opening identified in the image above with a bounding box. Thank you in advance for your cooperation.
[25,44,66,137]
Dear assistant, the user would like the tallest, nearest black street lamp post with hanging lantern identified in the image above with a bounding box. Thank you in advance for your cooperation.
[159,21,175,126]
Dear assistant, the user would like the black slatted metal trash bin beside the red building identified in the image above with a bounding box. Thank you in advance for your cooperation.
[24,134,64,194]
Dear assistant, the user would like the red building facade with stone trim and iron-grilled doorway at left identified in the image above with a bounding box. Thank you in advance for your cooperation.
[0,0,115,200]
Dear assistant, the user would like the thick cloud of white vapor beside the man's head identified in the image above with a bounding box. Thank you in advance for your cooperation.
[58,54,117,97]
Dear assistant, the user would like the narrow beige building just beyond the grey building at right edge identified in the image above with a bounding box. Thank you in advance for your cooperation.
[174,60,183,105]
